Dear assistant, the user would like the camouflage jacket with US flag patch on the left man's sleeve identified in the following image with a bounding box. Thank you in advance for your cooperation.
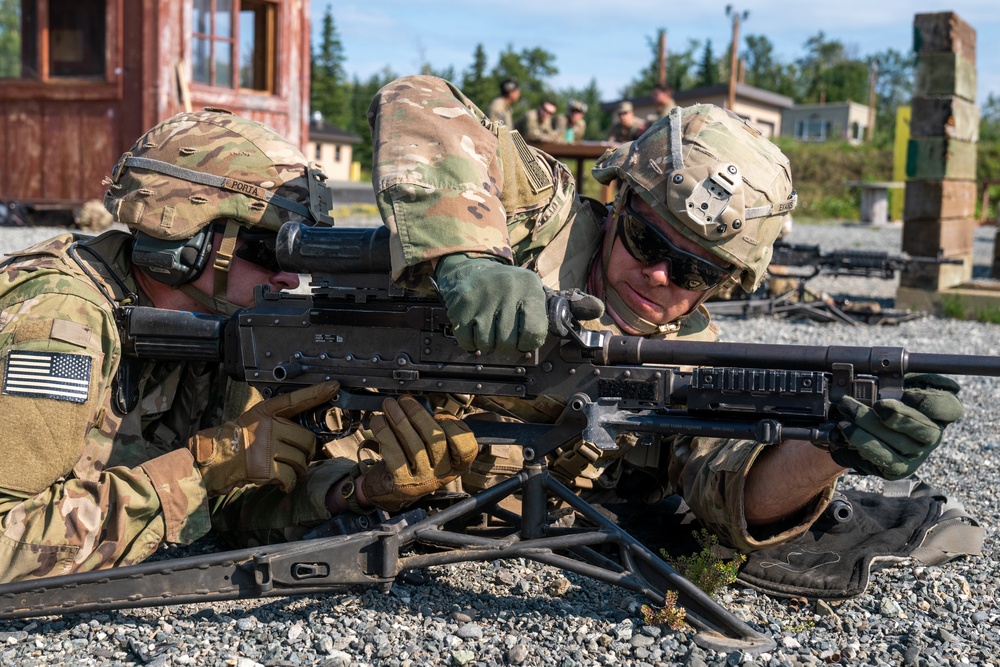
[0,232,343,582]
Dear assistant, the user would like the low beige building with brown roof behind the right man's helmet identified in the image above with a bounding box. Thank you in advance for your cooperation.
[620,83,792,138]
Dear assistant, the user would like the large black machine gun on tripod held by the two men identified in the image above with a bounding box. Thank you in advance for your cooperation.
[0,225,1000,651]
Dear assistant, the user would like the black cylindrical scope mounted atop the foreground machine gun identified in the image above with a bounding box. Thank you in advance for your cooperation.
[275,222,391,275]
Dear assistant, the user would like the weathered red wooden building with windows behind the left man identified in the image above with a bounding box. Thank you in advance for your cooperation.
[0,0,310,214]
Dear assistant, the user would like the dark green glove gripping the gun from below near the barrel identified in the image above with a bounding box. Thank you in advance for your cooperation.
[830,373,963,480]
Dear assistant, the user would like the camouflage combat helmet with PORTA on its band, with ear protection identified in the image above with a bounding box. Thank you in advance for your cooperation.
[104,108,333,313]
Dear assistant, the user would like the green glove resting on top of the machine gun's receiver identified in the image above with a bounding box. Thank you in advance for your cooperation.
[435,253,548,354]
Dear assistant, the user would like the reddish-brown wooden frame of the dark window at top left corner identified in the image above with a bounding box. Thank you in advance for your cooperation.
[0,0,124,100]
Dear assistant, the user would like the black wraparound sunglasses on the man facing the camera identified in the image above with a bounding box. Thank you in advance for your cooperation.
[615,197,733,292]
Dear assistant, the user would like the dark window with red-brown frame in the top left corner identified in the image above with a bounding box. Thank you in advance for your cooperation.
[0,0,107,81]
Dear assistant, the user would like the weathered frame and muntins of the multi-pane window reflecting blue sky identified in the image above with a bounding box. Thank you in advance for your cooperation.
[187,0,282,97]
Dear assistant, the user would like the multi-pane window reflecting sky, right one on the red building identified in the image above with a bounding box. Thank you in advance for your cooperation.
[192,0,277,93]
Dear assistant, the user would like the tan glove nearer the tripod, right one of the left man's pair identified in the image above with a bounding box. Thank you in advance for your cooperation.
[362,396,479,512]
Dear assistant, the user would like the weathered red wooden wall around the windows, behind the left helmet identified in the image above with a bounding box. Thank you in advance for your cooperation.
[0,0,309,206]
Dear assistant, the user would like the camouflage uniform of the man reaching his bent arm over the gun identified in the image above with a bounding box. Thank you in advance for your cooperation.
[368,76,833,549]
